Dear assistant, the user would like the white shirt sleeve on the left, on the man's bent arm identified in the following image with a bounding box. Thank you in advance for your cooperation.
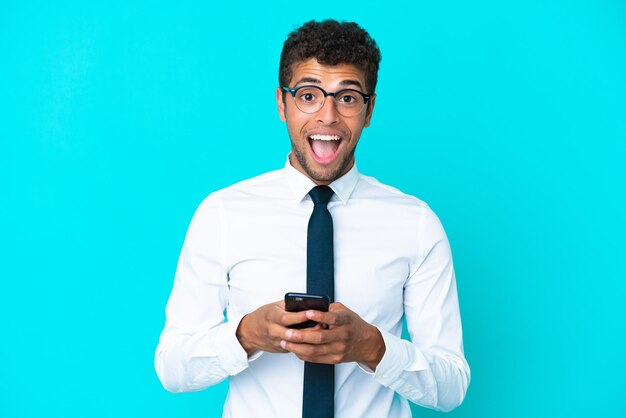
[154,195,248,392]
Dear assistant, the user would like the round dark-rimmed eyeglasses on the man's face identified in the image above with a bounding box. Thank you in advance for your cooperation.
[282,86,372,117]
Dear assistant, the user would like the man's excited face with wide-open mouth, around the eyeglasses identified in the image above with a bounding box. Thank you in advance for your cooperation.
[276,58,375,185]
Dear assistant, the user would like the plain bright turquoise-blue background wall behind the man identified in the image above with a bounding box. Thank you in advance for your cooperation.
[0,0,626,417]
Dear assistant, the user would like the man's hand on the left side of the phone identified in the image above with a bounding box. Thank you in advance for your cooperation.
[235,301,307,356]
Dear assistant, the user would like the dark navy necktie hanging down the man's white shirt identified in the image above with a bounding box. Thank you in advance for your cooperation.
[302,186,335,418]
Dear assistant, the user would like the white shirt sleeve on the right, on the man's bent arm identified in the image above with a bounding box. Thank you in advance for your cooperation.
[374,209,470,411]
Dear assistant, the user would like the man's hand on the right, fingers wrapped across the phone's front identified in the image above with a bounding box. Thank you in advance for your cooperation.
[280,303,385,370]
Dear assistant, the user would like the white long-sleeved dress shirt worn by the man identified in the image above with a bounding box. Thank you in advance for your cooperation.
[155,158,470,418]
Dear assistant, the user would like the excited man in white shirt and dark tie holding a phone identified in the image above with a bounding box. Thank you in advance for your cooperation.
[155,20,470,418]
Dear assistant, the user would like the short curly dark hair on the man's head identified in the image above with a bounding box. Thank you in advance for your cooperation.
[278,19,381,94]
